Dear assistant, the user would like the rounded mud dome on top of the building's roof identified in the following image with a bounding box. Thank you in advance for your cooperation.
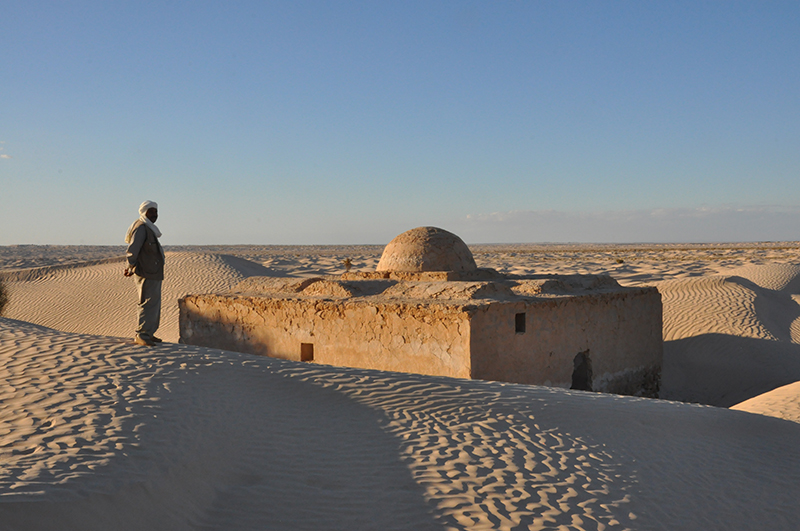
[376,227,478,272]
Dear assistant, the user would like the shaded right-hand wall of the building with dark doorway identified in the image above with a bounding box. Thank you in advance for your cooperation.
[470,288,663,396]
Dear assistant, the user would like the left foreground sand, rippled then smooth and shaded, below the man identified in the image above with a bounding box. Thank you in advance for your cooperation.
[0,319,438,530]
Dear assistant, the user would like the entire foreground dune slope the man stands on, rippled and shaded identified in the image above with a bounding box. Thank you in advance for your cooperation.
[0,319,800,530]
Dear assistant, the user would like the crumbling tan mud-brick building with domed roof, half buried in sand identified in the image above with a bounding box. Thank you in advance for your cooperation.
[179,227,662,396]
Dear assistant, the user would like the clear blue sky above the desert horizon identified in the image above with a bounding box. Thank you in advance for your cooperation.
[0,0,800,245]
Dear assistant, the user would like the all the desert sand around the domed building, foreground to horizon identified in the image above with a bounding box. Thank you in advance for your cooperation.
[0,242,800,530]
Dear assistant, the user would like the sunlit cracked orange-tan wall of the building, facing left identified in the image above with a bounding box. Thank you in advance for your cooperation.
[178,295,470,378]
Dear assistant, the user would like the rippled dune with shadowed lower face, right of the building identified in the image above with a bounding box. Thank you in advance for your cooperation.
[658,264,800,410]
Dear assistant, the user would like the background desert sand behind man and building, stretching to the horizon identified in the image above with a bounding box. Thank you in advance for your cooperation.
[4,244,800,414]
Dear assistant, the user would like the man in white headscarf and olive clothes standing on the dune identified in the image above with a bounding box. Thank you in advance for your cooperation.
[124,201,164,347]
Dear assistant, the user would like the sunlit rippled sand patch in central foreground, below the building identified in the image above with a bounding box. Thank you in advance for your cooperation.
[287,368,635,530]
